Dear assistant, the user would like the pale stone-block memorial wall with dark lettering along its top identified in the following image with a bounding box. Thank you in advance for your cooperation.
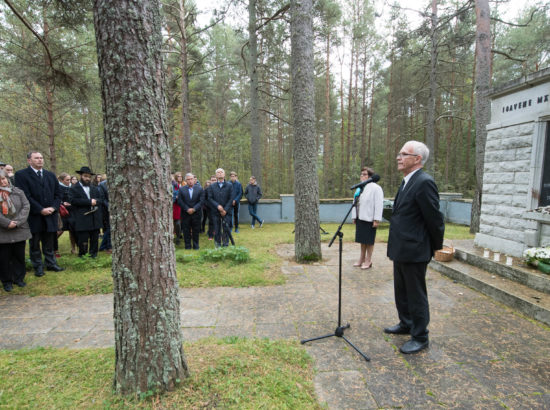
[475,70,550,257]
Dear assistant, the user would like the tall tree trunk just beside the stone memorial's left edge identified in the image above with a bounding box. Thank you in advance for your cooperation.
[470,0,491,233]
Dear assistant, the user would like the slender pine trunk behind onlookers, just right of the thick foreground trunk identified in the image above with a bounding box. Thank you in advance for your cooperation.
[178,0,193,172]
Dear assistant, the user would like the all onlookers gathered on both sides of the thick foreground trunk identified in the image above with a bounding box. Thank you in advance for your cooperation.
[0,155,264,292]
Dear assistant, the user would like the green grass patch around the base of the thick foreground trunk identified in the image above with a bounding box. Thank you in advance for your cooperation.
[0,337,320,409]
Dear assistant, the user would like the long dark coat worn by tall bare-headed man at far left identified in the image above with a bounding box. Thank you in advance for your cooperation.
[15,166,63,233]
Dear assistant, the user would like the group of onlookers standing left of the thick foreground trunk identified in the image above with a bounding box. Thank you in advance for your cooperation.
[0,151,111,292]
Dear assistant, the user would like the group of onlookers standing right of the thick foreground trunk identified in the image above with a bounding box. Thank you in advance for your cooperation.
[172,168,264,249]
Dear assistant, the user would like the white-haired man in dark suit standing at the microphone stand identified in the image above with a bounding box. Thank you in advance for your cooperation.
[384,141,445,354]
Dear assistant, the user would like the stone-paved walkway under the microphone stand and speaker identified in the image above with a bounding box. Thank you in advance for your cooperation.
[0,243,550,409]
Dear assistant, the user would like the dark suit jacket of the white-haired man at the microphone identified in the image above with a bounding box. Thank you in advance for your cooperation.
[388,169,445,263]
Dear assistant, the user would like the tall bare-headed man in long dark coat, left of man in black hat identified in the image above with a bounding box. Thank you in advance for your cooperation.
[15,151,64,277]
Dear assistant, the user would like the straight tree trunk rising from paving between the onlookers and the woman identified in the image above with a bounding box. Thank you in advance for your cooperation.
[290,0,321,262]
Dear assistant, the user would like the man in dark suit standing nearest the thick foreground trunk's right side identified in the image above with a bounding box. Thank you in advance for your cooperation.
[177,173,204,249]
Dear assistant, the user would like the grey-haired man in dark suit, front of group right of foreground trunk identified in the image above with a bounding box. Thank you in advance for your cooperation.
[208,168,234,246]
